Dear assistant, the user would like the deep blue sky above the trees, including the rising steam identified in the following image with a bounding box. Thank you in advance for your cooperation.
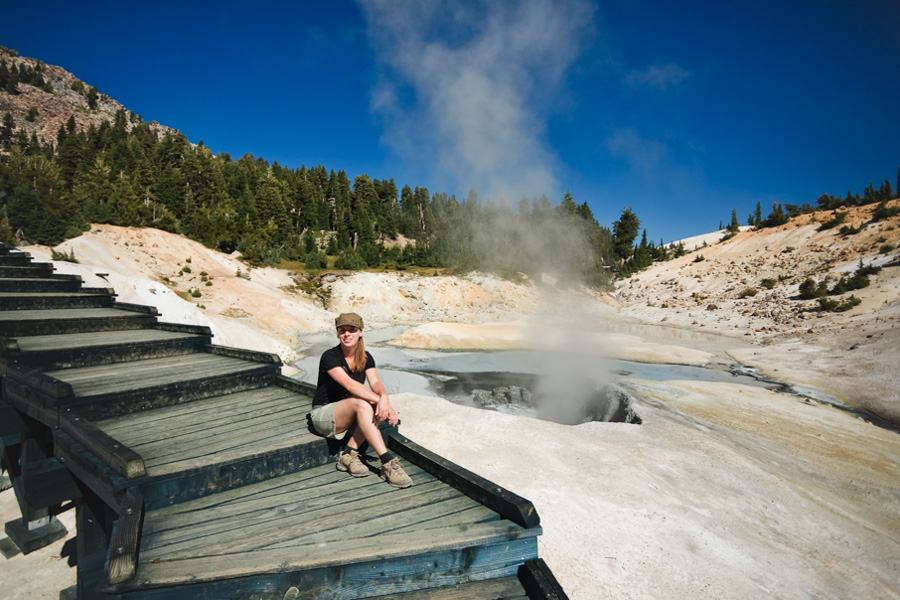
[0,0,900,242]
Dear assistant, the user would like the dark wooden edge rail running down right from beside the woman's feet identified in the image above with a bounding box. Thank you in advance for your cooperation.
[389,434,541,528]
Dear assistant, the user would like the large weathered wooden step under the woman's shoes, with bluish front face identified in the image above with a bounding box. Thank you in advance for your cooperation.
[107,463,540,599]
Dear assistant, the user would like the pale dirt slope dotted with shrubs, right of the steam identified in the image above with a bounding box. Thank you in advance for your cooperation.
[615,200,900,423]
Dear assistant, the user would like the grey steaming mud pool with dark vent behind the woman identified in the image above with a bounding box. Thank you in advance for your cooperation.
[293,328,785,425]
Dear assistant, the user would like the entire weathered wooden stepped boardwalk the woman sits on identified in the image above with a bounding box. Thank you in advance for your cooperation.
[0,246,565,600]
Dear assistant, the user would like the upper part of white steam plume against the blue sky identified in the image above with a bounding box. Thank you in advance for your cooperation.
[358,0,594,201]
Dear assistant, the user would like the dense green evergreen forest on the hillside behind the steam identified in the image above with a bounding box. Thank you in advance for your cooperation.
[0,110,665,285]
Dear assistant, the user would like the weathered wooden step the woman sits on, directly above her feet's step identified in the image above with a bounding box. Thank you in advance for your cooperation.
[87,385,326,508]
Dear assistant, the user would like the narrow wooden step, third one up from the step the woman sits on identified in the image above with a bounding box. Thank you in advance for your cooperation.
[0,304,156,337]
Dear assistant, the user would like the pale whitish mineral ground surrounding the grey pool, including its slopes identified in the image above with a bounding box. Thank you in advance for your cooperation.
[0,209,900,600]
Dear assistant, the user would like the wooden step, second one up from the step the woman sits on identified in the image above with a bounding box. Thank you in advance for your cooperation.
[7,322,212,371]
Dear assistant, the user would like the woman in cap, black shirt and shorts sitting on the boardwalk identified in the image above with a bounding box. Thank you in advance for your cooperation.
[310,313,412,488]
